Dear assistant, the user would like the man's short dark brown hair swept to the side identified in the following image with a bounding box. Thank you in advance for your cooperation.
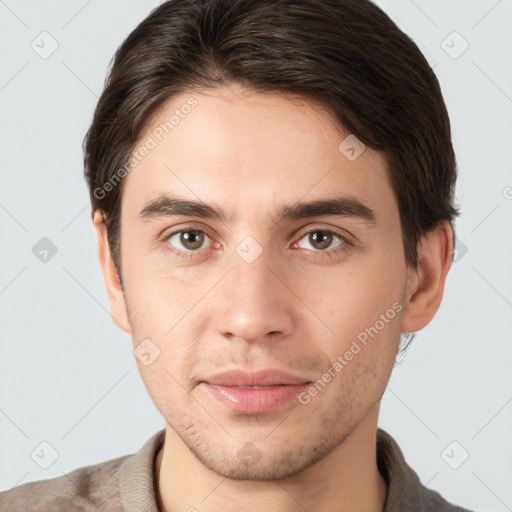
[84,0,458,276]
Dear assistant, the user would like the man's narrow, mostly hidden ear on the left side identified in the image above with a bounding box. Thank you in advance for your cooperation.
[93,210,131,333]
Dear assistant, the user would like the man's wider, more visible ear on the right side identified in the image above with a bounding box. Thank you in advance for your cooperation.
[401,221,453,332]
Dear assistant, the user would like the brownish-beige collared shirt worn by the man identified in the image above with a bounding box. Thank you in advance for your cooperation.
[0,429,470,512]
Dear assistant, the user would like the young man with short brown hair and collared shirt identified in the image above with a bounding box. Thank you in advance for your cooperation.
[0,0,474,512]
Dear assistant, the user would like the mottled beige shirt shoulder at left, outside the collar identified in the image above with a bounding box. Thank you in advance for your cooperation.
[0,455,131,512]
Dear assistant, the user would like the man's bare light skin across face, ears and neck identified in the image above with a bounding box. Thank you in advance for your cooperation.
[94,84,453,512]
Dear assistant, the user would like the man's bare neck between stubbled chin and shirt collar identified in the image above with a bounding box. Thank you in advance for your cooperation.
[155,410,387,512]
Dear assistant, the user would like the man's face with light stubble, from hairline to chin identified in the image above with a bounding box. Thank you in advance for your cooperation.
[114,85,408,480]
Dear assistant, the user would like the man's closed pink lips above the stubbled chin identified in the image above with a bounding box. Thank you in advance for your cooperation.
[200,370,311,414]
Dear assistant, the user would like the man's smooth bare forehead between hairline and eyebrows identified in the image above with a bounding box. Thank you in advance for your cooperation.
[123,85,396,221]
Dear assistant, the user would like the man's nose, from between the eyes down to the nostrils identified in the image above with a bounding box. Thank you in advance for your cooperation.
[213,244,297,343]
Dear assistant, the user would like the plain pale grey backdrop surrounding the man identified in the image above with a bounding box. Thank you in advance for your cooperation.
[0,0,512,511]
